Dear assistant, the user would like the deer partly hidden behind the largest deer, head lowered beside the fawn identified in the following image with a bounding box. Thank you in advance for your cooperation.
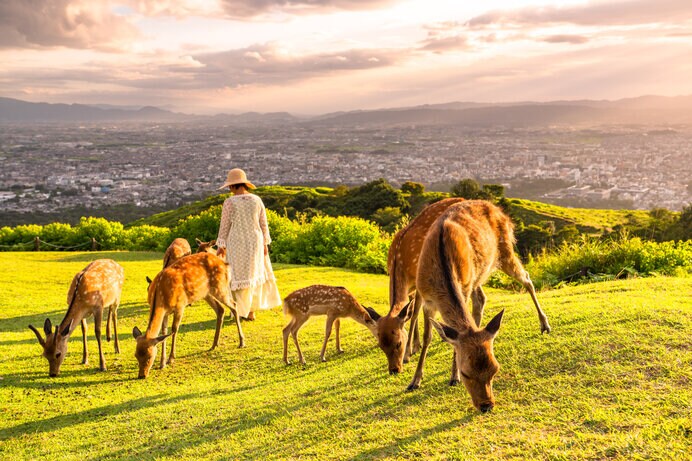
[368,198,464,374]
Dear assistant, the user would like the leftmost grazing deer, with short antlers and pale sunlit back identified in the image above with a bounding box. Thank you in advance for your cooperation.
[29,259,125,377]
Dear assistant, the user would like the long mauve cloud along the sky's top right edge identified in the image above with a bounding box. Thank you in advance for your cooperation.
[467,0,692,28]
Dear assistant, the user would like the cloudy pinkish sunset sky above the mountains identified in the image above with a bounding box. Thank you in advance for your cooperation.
[0,0,692,115]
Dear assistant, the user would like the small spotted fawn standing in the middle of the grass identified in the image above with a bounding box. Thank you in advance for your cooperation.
[283,285,376,365]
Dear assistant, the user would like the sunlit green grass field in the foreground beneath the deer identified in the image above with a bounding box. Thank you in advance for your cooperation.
[0,252,692,460]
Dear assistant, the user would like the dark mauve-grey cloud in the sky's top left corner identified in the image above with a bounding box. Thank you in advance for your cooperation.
[0,0,139,51]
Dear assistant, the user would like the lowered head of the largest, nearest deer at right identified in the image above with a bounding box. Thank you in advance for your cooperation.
[430,310,505,413]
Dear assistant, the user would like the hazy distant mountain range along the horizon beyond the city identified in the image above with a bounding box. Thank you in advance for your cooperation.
[0,96,692,128]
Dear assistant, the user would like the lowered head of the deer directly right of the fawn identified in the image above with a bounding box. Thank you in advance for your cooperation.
[365,300,413,375]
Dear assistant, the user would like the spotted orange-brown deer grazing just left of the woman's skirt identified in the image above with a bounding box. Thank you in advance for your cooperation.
[132,252,245,378]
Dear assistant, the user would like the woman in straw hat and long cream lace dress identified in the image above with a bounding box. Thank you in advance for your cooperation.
[216,168,281,320]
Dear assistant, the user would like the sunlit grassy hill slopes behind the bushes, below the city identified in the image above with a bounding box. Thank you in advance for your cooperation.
[130,186,651,233]
